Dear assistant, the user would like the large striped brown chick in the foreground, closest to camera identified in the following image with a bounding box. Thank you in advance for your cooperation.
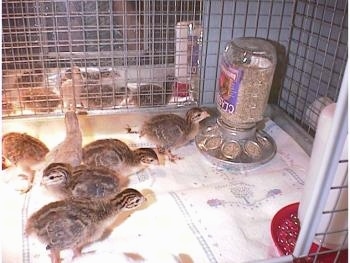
[26,188,146,263]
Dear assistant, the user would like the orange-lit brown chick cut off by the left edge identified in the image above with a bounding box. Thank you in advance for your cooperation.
[2,132,49,193]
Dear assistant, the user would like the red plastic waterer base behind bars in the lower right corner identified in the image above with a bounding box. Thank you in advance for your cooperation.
[271,203,348,263]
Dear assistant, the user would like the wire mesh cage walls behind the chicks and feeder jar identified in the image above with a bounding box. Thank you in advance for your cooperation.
[2,0,348,260]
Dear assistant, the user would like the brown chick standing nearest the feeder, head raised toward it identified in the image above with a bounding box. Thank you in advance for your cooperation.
[140,107,209,161]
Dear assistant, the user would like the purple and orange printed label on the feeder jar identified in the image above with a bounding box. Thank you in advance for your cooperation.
[218,63,243,113]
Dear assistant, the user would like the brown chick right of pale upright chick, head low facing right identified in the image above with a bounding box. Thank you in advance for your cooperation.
[83,139,159,175]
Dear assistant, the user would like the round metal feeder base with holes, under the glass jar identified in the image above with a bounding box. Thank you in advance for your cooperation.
[195,119,276,171]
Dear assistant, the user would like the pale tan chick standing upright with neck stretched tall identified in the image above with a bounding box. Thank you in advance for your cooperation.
[46,111,83,167]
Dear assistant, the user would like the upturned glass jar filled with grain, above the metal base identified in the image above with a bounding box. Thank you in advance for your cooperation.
[217,37,277,129]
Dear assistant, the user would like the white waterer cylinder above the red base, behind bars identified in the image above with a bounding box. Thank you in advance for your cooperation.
[298,103,348,249]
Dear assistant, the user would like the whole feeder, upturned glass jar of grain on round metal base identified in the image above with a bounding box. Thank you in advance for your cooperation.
[196,37,277,170]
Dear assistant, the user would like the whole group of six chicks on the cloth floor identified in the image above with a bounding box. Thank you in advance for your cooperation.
[2,107,209,263]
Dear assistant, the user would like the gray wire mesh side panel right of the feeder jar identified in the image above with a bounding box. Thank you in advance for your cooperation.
[279,1,348,132]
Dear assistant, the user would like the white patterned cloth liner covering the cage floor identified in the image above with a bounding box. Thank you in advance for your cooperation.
[2,120,309,263]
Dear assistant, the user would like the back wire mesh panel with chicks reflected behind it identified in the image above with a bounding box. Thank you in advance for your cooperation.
[2,0,202,117]
